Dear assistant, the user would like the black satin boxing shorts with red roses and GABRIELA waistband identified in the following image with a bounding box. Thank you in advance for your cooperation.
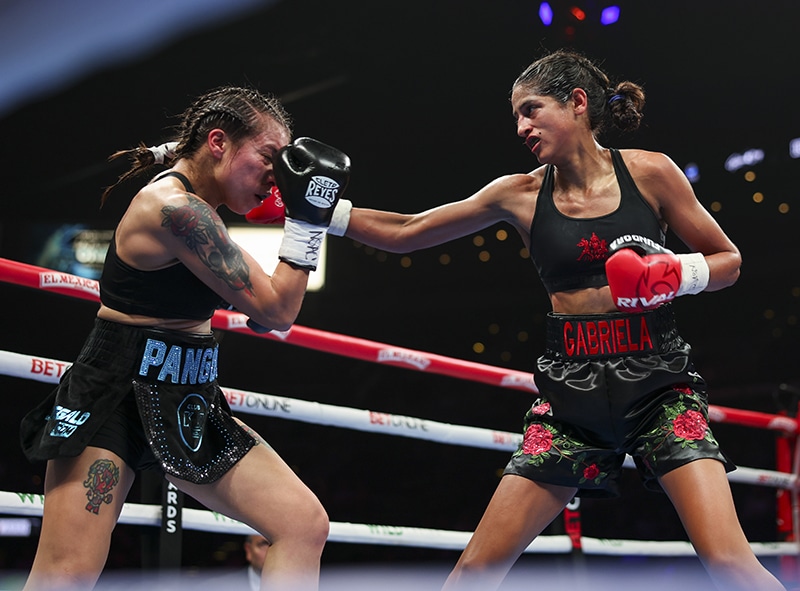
[504,305,736,497]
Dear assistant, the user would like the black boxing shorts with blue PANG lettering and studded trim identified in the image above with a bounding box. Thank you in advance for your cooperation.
[20,319,255,484]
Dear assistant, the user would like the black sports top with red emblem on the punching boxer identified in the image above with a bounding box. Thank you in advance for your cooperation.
[530,149,666,293]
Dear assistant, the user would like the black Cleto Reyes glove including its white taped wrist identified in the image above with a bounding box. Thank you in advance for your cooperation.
[275,137,350,270]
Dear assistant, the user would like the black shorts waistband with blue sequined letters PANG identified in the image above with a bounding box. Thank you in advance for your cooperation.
[77,318,219,384]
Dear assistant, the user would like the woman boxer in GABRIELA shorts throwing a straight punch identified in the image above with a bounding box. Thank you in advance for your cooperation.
[330,50,783,591]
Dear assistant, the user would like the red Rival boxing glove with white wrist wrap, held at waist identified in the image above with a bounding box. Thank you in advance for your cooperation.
[606,234,709,312]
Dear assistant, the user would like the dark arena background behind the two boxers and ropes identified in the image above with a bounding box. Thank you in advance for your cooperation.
[0,0,800,589]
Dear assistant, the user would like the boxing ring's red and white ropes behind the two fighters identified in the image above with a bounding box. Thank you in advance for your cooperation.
[0,258,800,586]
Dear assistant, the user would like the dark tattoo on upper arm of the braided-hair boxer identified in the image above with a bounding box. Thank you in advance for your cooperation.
[166,194,253,293]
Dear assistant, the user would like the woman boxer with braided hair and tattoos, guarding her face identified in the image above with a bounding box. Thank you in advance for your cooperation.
[21,87,350,591]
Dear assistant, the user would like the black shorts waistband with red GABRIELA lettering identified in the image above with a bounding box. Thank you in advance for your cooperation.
[545,304,684,361]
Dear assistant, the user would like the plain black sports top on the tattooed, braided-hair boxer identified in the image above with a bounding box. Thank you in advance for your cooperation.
[100,170,224,320]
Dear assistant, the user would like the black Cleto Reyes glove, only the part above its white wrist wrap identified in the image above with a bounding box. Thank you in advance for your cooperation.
[275,137,350,227]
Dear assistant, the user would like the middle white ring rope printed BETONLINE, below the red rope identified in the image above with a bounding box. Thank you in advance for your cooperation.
[0,351,798,490]
